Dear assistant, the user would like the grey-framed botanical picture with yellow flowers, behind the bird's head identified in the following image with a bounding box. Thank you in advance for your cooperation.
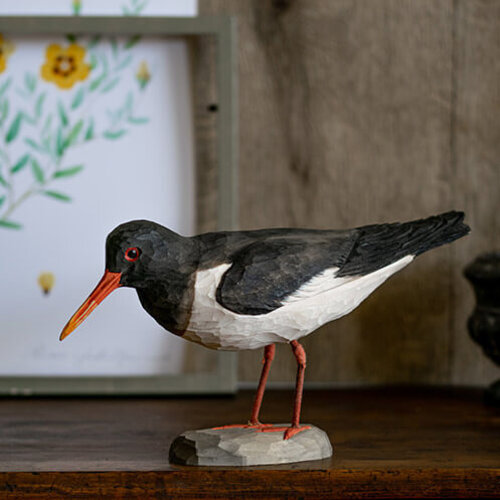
[0,16,237,395]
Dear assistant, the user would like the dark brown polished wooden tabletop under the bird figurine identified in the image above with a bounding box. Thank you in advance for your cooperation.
[0,388,500,498]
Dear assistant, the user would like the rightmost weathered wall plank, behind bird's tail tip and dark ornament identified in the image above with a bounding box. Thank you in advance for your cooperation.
[451,0,500,384]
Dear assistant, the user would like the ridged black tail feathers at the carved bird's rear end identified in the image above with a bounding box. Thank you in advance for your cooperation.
[337,212,470,276]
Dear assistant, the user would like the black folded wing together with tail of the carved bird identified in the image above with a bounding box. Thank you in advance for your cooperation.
[216,212,469,315]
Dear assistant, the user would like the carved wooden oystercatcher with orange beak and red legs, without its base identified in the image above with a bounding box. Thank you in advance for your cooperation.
[60,212,469,439]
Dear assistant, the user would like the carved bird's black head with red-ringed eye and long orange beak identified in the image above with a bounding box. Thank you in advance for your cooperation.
[60,220,196,340]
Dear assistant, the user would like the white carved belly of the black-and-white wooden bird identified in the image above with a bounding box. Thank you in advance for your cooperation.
[183,255,414,350]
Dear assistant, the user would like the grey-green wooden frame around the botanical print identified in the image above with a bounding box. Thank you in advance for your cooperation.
[0,16,238,396]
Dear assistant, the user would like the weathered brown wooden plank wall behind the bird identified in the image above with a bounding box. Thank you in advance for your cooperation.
[195,0,500,384]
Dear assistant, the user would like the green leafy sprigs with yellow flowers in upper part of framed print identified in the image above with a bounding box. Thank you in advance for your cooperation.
[0,35,151,229]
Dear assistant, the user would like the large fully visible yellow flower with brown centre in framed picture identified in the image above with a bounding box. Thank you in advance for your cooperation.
[40,43,90,89]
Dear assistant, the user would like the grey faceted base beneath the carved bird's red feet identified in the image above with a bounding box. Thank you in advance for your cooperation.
[170,424,333,466]
